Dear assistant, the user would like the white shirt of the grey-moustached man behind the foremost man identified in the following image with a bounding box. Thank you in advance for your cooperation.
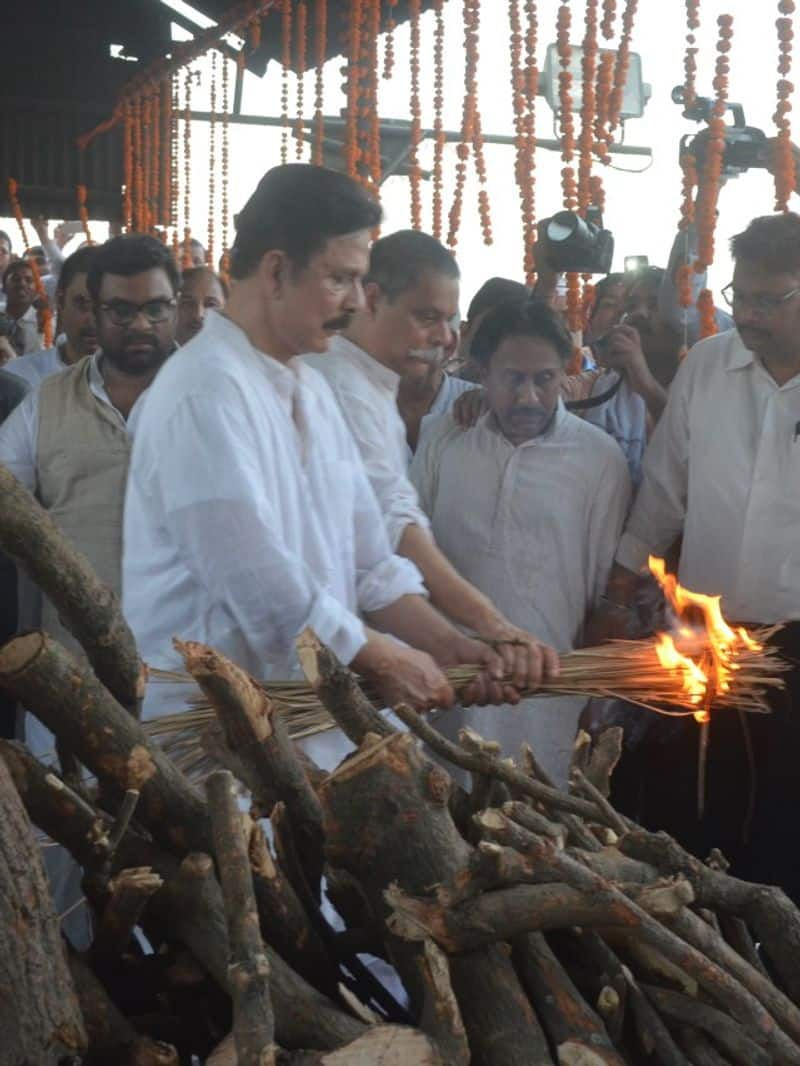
[303,337,429,550]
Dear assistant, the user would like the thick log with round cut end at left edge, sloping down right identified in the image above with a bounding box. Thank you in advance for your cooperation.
[0,632,211,855]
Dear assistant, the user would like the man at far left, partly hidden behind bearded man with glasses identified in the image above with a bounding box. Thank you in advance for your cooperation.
[6,247,98,386]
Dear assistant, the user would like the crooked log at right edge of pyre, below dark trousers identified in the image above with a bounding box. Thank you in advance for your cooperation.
[620,829,800,1004]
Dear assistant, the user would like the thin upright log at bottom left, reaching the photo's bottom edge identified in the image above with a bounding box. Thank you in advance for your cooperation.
[206,770,276,1066]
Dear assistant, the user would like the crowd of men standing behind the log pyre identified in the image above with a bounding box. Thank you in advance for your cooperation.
[0,164,800,916]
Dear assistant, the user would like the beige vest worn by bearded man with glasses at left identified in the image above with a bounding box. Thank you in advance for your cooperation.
[36,356,131,650]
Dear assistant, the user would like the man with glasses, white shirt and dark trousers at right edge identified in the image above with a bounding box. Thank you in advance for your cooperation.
[607,213,800,900]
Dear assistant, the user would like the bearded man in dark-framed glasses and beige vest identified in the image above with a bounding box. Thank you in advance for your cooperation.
[0,236,178,665]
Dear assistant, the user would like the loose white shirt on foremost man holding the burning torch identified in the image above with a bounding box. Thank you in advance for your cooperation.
[123,311,423,695]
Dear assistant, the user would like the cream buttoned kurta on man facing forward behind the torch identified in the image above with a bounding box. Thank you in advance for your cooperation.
[412,405,630,784]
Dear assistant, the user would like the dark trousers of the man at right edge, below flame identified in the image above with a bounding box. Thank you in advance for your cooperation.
[612,623,800,903]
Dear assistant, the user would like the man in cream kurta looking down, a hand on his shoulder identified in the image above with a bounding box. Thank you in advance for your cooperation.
[412,301,630,785]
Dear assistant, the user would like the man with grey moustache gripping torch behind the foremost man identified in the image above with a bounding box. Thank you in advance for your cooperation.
[307,230,555,688]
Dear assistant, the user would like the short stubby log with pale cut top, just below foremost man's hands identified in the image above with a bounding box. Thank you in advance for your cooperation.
[297,629,396,746]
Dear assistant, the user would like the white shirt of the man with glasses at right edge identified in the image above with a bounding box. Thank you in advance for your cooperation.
[617,330,800,624]
